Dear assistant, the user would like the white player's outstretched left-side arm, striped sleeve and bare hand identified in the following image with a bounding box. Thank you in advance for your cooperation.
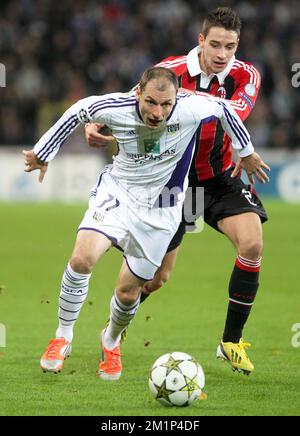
[23,96,110,182]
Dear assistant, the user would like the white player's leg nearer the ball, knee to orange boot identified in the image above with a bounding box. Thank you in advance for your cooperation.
[98,261,145,380]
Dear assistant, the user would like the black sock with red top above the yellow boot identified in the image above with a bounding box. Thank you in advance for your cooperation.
[223,256,261,343]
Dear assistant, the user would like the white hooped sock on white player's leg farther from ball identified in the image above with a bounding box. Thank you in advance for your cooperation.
[56,263,91,342]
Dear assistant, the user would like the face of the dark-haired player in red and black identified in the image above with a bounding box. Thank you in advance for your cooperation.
[198,27,239,74]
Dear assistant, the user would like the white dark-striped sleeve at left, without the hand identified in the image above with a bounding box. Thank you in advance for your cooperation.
[33,96,116,162]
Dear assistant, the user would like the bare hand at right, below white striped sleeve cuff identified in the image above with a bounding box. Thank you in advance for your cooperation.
[231,152,271,185]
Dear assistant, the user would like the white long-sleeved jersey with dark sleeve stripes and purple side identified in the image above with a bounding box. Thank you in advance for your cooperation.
[34,92,254,207]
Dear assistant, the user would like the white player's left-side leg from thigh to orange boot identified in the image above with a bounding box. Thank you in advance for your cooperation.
[40,230,112,372]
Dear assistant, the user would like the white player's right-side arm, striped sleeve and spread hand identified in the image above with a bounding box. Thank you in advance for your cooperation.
[215,99,270,184]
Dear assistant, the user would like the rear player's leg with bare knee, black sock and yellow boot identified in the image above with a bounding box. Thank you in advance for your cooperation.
[218,212,263,373]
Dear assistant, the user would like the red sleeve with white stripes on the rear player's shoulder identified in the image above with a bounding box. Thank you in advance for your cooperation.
[228,64,261,121]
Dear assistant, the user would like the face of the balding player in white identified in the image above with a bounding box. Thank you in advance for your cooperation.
[136,79,176,129]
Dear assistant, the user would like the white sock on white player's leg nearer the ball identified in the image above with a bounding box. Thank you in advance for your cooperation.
[103,293,140,350]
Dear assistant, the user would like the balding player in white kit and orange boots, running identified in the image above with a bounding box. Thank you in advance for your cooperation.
[24,67,264,380]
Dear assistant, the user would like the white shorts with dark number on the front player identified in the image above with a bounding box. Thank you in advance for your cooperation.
[78,169,182,280]
